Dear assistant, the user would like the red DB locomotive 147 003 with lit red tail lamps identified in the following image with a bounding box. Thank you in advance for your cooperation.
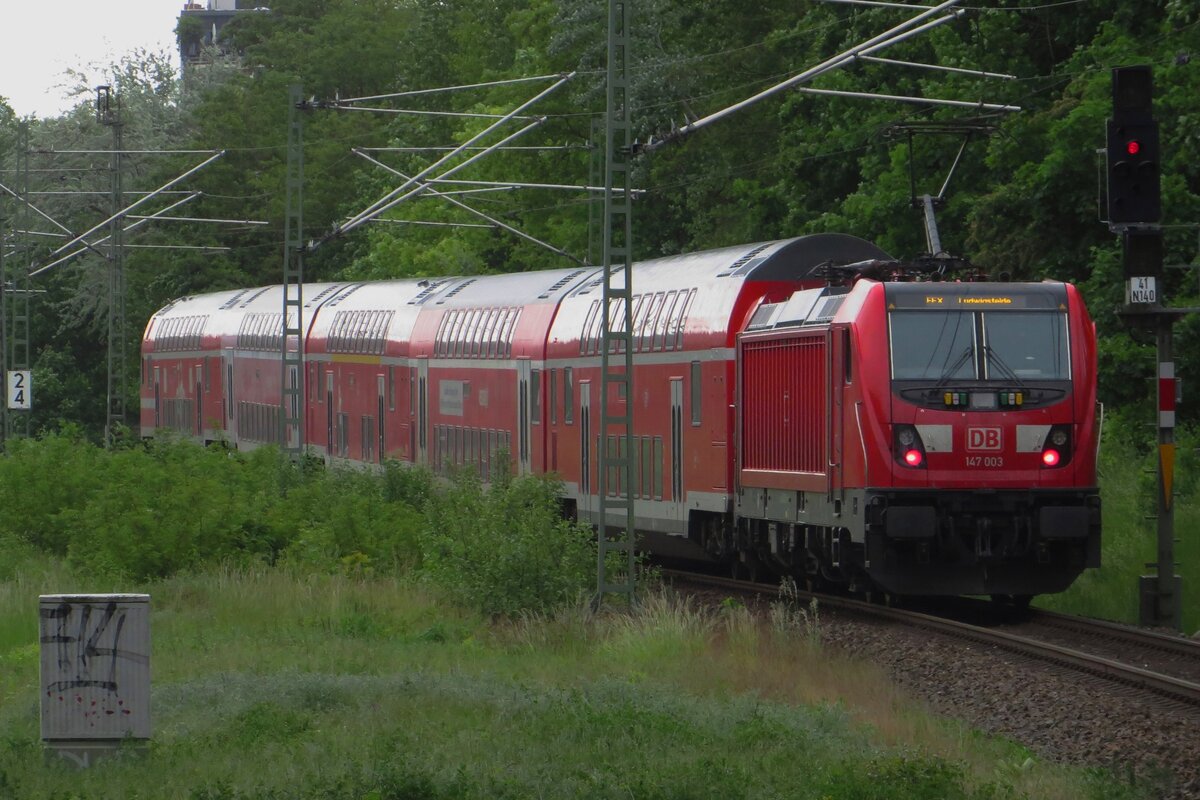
[737,279,1100,600]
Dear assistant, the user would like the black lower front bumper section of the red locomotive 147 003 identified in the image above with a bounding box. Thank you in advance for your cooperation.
[864,488,1100,595]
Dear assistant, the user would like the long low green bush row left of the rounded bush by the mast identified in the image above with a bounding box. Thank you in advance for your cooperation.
[0,434,431,579]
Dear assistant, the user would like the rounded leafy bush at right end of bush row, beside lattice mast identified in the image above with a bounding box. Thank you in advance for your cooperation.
[421,459,596,615]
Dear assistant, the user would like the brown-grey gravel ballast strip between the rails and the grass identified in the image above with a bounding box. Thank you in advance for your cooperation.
[821,609,1200,800]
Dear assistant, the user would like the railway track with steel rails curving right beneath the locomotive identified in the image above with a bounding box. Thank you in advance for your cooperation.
[664,571,1200,710]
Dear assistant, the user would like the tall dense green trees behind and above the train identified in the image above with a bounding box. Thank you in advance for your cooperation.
[0,0,1200,435]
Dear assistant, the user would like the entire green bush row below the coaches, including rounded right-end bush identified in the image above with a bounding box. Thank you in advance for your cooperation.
[0,435,596,615]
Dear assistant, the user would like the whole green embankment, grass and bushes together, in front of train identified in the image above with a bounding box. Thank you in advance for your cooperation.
[0,431,1180,800]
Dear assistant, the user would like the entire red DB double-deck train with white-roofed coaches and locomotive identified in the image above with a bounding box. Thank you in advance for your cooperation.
[140,234,1100,599]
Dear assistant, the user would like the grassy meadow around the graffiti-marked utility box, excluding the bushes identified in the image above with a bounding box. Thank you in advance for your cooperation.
[0,565,1136,800]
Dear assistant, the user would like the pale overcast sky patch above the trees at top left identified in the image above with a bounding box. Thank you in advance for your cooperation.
[0,0,182,119]
